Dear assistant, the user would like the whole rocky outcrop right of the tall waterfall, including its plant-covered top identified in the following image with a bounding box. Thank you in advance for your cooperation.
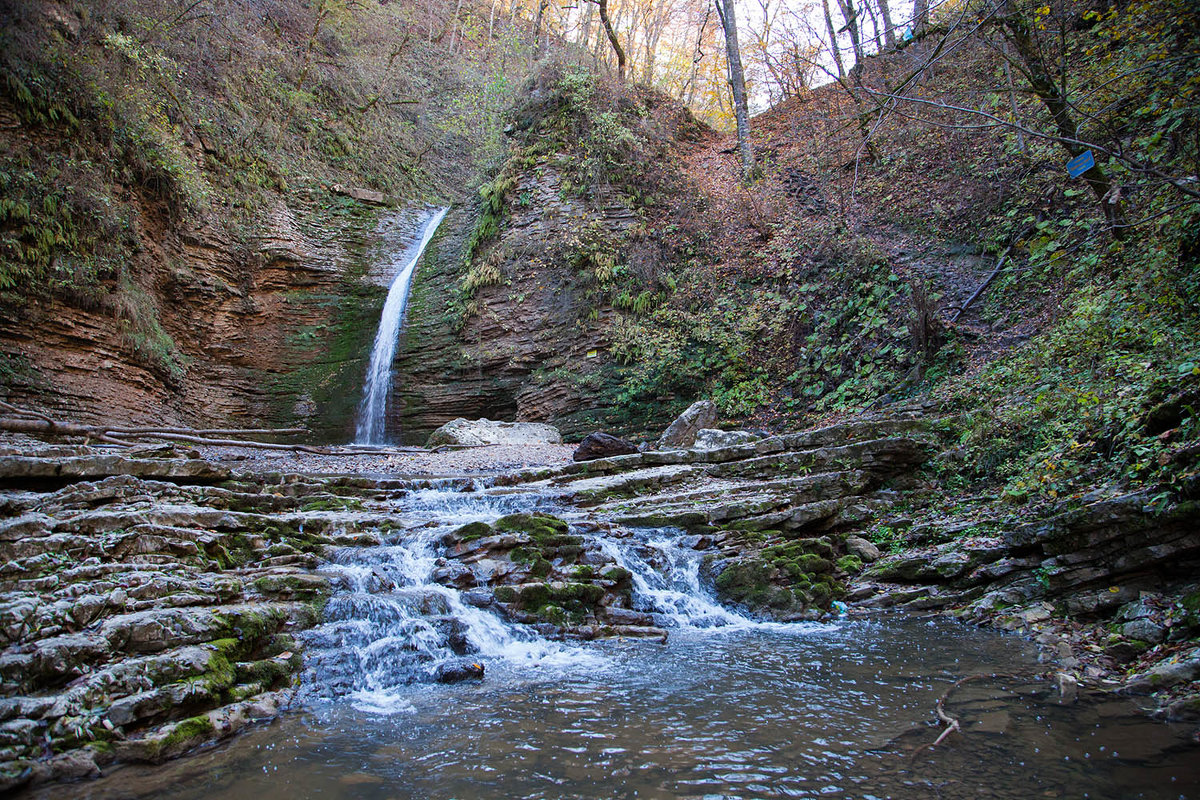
[394,72,702,443]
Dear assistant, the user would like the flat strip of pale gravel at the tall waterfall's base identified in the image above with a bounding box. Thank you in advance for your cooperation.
[199,445,575,477]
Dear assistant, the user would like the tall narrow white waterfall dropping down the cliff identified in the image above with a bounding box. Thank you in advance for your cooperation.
[354,209,450,445]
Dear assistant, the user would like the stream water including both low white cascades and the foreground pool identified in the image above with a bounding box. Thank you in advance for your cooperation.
[41,488,1200,800]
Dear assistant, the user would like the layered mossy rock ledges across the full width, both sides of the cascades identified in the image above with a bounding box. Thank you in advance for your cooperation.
[0,409,1200,788]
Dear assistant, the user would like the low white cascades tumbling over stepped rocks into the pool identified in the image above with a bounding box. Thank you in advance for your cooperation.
[304,485,777,714]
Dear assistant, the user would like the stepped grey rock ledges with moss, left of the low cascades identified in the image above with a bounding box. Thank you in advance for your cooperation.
[0,447,408,789]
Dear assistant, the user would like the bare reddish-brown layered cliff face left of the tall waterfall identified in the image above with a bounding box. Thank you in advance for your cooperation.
[0,183,384,440]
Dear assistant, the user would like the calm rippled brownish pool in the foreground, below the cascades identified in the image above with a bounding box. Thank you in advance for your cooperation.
[40,618,1200,800]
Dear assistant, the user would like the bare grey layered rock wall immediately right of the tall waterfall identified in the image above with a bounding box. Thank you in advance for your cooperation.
[395,169,637,441]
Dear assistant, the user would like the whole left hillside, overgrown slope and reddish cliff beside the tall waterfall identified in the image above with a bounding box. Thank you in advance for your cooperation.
[0,0,521,440]
